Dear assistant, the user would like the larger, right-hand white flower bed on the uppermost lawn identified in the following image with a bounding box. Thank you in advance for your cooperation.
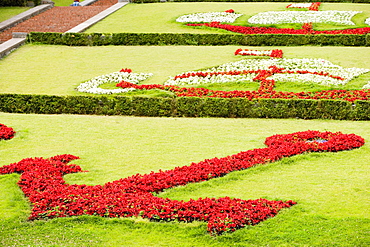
[248,10,362,25]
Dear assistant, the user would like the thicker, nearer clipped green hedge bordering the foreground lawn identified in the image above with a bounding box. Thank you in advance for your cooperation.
[0,94,370,120]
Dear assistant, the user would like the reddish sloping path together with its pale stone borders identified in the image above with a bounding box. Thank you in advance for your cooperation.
[0,0,129,59]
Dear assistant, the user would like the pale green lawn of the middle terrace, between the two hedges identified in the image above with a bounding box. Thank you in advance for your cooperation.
[0,44,370,95]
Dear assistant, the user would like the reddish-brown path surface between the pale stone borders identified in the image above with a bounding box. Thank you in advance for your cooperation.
[0,0,118,44]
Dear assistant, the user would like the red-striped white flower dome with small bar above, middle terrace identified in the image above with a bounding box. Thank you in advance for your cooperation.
[165,56,370,86]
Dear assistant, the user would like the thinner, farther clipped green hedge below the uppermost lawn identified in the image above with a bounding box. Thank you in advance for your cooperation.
[28,32,370,46]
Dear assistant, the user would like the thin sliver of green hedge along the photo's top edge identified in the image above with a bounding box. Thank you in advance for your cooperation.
[131,0,370,3]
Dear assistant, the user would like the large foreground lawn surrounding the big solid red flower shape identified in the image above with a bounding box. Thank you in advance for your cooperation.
[0,113,370,246]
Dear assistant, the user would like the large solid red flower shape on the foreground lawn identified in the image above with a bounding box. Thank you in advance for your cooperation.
[0,131,364,235]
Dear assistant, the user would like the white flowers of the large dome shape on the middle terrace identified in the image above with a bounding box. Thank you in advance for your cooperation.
[165,58,370,85]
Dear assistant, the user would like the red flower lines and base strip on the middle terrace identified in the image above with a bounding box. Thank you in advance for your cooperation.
[116,66,370,102]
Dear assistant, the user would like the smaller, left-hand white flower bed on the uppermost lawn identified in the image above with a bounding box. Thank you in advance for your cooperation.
[176,12,242,23]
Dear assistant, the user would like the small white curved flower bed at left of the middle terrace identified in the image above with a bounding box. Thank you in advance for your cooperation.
[77,72,153,94]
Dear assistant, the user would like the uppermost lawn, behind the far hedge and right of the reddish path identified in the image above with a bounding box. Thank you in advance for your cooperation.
[85,2,370,33]
